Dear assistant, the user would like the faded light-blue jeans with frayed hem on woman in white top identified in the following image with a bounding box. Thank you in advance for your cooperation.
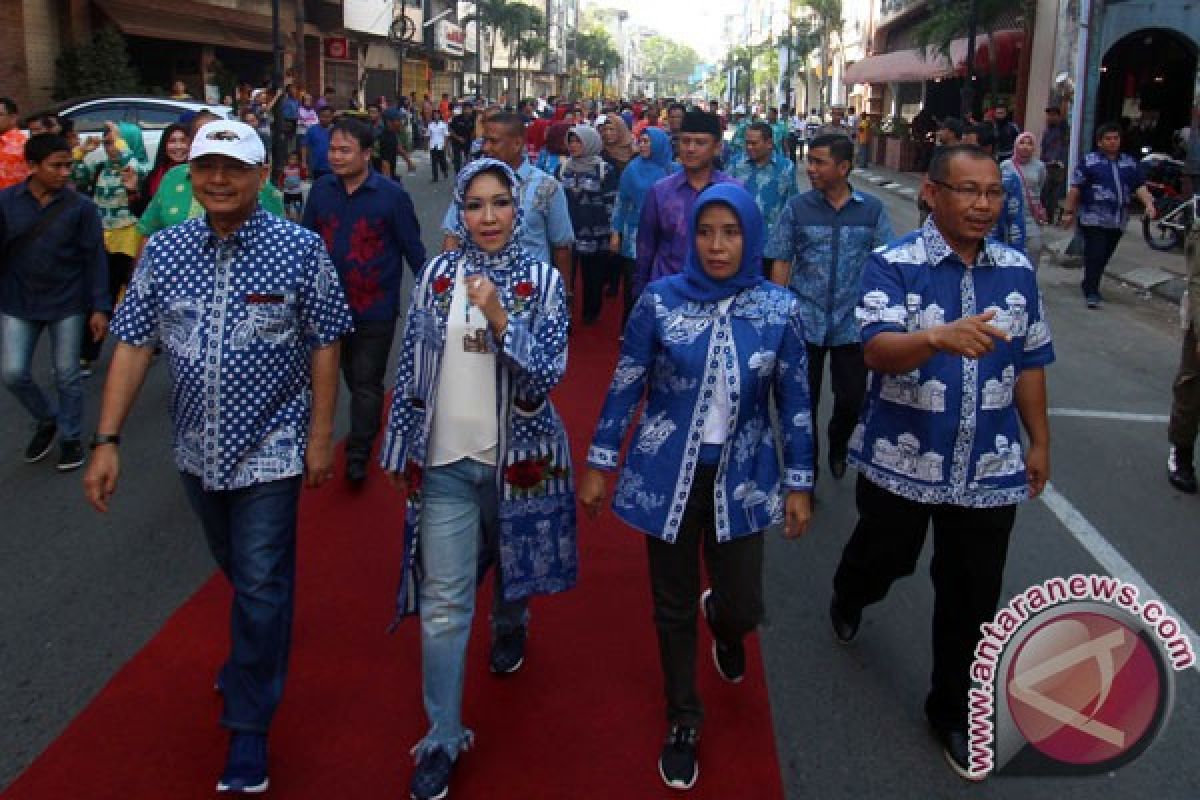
[416,458,528,758]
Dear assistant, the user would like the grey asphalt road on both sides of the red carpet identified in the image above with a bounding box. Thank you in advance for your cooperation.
[0,154,1200,800]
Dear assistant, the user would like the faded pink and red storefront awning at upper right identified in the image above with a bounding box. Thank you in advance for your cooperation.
[845,30,1025,84]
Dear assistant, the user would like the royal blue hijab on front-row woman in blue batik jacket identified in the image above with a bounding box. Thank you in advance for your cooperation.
[667,184,764,303]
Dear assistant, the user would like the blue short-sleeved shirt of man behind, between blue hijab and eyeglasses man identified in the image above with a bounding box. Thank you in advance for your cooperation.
[764,190,892,347]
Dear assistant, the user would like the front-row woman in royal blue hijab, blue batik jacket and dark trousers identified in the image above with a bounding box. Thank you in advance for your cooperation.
[580,184,814,789]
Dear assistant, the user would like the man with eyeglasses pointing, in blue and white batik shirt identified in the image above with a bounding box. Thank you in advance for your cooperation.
[829,145,1054,780]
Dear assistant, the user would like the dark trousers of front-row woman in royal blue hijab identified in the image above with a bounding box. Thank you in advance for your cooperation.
[646,464,763,728]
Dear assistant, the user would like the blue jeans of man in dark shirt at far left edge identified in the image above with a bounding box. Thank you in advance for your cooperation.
[0,314,84,439]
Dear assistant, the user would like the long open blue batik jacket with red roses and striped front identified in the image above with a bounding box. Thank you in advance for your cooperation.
[380,251,578,619]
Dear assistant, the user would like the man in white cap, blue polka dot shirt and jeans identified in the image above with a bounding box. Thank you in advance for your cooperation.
[84,120,352,793]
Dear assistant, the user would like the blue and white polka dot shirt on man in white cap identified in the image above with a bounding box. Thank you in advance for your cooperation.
[112,207,353,492]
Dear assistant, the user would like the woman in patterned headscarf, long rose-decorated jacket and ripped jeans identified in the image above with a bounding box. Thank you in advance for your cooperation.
[382,158,577,799]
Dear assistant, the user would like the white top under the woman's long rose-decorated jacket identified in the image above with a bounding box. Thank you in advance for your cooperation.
[428,263,499,467]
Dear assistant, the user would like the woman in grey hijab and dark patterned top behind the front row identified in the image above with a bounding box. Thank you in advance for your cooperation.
[558,124,617,325]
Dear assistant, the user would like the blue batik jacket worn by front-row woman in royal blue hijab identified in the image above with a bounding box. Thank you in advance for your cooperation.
[588,281,814,542]
